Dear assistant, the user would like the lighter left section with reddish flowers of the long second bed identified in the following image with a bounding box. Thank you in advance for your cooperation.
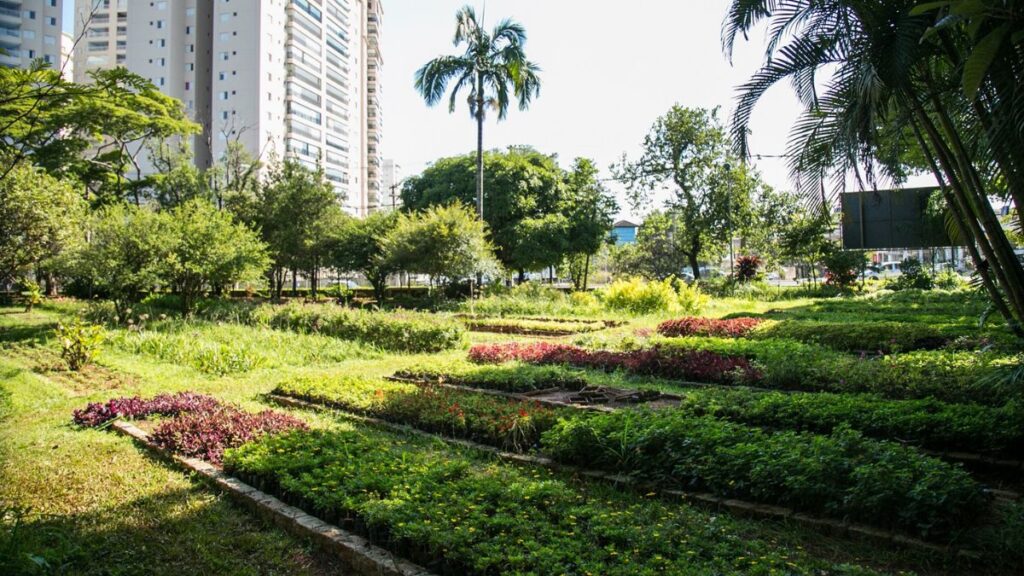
[273,377,562,452]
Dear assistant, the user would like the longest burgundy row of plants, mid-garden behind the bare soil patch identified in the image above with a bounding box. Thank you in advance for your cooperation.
[469,342,761,384]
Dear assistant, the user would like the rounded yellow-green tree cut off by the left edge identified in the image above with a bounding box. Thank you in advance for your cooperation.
[0,159,85,284]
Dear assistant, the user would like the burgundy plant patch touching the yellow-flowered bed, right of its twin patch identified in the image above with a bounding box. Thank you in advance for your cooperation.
[151,406,308,464]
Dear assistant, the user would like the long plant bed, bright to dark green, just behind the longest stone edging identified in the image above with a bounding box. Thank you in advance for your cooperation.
[276,373,985,537]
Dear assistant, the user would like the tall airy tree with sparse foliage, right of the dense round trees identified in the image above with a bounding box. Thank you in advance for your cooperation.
[611,105,756,279]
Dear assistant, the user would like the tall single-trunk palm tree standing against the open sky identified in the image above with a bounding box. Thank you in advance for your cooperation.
[416,6,541,219]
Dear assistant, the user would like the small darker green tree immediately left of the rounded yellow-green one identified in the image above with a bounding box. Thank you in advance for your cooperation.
[330,212,399,302]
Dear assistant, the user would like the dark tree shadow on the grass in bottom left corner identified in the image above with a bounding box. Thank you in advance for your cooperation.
[0,487,345,576]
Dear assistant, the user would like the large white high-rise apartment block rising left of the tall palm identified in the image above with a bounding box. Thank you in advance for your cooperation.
[73,0,383,215]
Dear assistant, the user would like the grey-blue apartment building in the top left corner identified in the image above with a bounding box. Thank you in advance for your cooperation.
[0,0,63,69]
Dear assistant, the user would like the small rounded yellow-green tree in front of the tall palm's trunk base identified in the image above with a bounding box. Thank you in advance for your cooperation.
[385,204,498,282]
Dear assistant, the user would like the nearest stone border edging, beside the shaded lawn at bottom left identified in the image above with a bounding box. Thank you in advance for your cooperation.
[112,420,435,576]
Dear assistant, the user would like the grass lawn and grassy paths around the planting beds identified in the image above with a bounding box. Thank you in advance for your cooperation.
[0,293,1015,574]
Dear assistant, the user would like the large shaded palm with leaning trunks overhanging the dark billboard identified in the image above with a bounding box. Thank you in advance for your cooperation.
[722,0,1024,334]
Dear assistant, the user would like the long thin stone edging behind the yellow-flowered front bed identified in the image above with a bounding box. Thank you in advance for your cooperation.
[267,394,981,559]
